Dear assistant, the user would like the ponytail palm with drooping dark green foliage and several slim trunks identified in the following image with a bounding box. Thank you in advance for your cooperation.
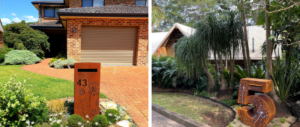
[175,11,243,92]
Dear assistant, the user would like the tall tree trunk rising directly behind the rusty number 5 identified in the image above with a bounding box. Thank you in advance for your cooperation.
[266,0,291,118]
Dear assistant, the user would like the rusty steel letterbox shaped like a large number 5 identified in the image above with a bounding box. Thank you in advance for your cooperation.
[238,78,276,127]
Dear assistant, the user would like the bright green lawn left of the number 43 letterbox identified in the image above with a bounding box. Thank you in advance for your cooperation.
[0,65,107,100]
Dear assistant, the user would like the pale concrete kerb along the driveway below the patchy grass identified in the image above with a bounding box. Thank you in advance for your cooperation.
[152,103,210,127]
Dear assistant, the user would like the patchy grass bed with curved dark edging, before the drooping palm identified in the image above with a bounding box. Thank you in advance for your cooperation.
[152,92,235,127]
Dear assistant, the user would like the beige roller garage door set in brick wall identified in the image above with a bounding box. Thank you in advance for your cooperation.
[81,26,137,65]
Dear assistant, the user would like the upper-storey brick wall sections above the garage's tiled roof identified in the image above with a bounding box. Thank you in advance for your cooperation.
[69,0,135,8]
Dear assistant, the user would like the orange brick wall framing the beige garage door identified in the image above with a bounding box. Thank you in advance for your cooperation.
[67,18,148,66]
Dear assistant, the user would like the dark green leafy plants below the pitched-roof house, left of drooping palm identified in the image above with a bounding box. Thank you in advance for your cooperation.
[152,55,207,91]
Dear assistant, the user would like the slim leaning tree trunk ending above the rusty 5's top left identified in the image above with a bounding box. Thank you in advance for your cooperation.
[241,0,251,76]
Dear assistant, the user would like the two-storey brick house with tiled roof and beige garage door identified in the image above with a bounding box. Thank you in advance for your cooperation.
[30,0,148,66]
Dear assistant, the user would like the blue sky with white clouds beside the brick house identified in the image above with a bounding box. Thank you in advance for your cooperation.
[0,0,39,25]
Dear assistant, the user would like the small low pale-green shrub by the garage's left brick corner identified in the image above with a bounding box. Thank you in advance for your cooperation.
[50,58,77,69]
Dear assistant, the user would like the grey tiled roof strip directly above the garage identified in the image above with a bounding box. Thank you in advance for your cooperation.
[59,5,148,14]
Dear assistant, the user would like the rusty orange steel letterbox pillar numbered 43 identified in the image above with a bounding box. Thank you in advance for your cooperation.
[74,63,101,120]
